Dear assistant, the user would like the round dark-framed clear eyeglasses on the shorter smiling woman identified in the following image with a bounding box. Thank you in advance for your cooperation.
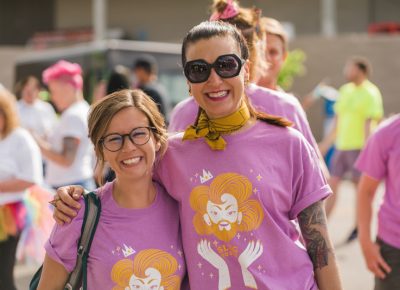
[100,127,157,152]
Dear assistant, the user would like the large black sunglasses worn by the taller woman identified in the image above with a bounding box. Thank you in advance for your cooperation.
[184,54,245,83]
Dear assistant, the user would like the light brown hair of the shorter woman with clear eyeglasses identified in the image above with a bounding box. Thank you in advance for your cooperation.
[88,90,167,184]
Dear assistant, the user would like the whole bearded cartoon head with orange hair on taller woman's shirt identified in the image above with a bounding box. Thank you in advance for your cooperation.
[190,173,264,242]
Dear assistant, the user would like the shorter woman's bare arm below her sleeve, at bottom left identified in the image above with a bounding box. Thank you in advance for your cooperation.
[37,254,68,290]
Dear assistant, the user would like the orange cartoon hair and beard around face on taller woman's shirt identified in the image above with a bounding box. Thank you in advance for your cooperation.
[190,173,264,242]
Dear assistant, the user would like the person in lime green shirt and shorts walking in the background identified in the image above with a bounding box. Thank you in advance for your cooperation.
[320,57,383,241]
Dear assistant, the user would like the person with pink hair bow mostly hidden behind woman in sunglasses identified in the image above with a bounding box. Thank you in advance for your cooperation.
[168,0,327,157]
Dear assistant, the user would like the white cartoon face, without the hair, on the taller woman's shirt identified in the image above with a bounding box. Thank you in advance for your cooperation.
[204,193,242,231]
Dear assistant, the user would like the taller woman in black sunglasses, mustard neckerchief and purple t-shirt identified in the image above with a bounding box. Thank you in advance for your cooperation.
[51,21,342,290]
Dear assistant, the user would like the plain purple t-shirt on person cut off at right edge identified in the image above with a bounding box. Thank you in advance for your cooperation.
[355,115,400,249]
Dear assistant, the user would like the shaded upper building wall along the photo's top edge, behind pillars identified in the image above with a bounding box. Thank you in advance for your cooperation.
[0,0,400,45]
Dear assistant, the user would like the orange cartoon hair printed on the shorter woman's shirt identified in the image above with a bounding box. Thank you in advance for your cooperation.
[111,249,181,290]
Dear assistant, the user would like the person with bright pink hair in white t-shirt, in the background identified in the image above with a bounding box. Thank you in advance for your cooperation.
[35,60,95,189]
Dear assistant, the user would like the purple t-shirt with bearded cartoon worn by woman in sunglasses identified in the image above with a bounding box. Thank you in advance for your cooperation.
[156,121,331,290]
